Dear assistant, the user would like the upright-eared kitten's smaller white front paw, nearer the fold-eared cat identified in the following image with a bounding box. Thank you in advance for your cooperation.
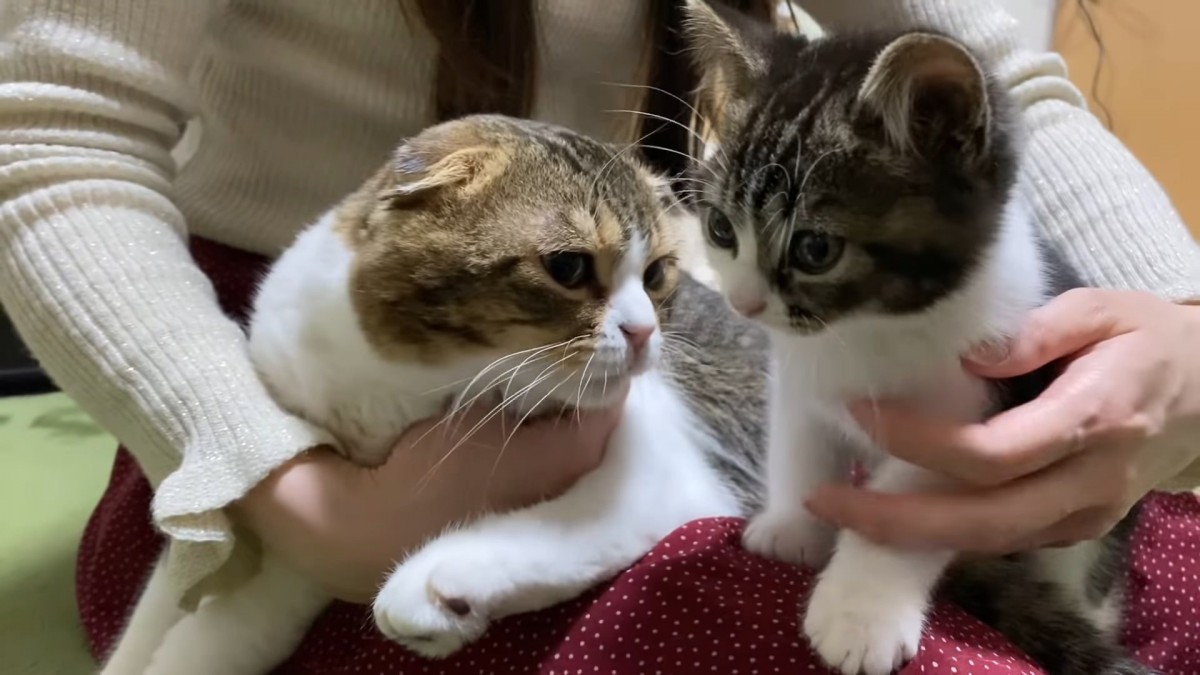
[742,510,838,569]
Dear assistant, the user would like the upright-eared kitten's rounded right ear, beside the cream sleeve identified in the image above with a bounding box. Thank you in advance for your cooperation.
[858,32,991,154]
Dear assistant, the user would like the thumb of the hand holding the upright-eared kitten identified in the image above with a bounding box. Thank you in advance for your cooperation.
[964,288,1124,378]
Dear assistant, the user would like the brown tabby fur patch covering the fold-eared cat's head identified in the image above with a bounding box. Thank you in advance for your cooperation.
[338,115,679,368]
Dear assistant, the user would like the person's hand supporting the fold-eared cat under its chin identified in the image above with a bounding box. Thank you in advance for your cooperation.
[235,405,619,602]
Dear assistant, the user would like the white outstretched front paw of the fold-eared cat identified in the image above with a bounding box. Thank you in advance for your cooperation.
[373,555,491,658]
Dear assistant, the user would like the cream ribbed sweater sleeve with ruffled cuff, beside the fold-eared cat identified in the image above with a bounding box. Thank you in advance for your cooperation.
[0,0,326,593]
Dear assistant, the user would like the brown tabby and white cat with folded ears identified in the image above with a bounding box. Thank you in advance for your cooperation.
[98,117,768,675]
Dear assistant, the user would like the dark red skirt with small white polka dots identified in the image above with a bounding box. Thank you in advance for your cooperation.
[77,243,1200,675]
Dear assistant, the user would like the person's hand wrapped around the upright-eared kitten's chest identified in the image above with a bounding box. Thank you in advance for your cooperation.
[808,289,1200,554]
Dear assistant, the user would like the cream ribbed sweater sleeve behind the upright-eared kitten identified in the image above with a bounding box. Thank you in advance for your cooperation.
[804,0,1200,301]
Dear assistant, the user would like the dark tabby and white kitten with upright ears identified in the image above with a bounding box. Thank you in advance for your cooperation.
[688,5,1147,675]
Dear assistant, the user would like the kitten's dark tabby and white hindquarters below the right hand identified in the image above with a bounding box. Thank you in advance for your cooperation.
[942,508,1159,675]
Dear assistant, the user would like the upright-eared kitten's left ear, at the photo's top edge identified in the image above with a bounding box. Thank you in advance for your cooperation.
[683,0,779,136]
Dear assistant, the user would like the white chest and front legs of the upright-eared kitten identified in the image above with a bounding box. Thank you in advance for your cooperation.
[745,196,1046,675]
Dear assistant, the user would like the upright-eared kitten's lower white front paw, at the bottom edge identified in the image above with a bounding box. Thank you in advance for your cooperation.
[804,566,928,675]
